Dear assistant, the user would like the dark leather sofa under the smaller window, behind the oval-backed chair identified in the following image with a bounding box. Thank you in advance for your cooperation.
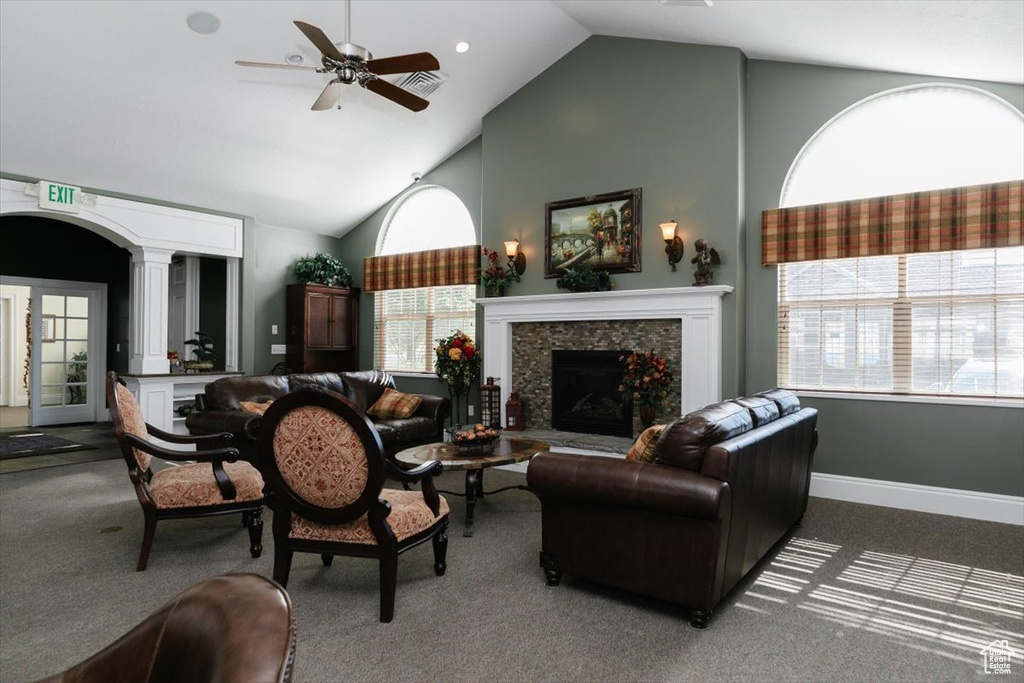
[185,370,451,463]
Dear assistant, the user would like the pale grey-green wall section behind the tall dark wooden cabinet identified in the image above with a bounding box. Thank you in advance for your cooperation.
[240,221,351,375]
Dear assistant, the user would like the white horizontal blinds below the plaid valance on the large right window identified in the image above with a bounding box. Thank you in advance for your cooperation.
[778,247,1024,397]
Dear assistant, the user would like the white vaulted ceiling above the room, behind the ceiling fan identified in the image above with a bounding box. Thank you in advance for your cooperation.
[0,0,1024,234]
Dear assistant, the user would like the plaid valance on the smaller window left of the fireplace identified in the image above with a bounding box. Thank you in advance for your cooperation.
[362,245,480,292]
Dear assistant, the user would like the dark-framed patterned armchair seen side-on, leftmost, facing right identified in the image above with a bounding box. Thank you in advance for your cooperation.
[106,372,264,571]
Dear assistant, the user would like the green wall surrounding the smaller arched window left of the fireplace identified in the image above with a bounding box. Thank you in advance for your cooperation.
[338,137,481,404]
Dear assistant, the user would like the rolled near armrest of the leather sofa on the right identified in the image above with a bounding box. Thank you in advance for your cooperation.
[526,453,729,520]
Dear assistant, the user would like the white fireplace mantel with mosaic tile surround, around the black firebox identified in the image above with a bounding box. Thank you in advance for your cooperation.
[476,285,732,433]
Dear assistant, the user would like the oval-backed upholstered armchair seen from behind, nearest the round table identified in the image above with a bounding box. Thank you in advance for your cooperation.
[256,386,449,623]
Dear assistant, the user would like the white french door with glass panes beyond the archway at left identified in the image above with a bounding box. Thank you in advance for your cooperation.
[30,283,106,427]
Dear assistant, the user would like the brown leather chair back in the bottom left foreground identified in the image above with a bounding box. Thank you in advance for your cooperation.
[39,573,295,683]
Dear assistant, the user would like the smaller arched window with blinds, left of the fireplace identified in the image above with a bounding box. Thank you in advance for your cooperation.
[374,185,476,373]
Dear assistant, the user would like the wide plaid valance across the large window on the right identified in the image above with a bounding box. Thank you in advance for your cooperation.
[761,180,1024,265]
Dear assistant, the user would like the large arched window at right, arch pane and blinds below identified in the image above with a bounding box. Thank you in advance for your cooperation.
[778,85,1024,397]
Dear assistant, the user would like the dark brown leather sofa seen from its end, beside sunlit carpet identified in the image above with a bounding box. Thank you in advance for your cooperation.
[526,389,817,629]
